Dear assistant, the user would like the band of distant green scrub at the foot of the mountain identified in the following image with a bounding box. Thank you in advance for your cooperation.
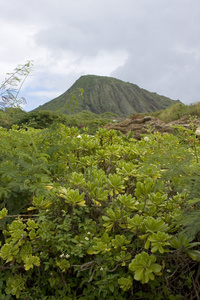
[0,97,200,134]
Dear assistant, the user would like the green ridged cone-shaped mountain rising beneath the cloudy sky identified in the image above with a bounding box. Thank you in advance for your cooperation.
[35,75,179,117]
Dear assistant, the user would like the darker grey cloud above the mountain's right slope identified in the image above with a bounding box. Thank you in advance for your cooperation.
[111,51,200,104]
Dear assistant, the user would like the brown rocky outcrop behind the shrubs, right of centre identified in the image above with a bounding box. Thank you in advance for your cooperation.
[104,116,200,140]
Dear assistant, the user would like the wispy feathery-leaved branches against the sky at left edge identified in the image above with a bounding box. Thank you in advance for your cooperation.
[0,60,33,108]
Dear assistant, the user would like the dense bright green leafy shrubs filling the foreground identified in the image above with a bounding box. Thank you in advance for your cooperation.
[0,124,200,300]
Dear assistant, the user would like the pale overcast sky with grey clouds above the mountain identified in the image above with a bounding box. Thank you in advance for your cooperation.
[0,0,200,111]
